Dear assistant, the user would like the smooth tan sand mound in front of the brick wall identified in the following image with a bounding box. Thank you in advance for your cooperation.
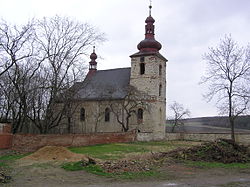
[22,146,89,162]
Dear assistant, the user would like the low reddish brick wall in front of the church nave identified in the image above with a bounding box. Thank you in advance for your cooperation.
[12,132,136,152]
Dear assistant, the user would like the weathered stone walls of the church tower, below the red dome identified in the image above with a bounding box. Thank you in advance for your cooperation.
[130,55,166,141]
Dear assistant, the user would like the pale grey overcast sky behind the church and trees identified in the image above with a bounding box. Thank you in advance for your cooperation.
[0,0,250,117]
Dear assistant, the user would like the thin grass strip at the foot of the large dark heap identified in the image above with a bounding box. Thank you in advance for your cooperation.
[185,161,250,169]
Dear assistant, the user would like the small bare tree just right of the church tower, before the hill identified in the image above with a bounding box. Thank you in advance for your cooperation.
[169,101,190,132]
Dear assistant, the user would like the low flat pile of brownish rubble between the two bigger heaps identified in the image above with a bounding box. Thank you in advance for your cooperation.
[101,160,152,173]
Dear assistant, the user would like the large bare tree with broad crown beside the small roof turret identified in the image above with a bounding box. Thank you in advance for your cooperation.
[27,16,104,133]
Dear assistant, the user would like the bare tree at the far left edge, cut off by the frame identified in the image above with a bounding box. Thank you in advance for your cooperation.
[0,21,39,133]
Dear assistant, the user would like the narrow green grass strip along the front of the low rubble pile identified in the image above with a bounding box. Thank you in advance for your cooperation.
[61,161,161,179]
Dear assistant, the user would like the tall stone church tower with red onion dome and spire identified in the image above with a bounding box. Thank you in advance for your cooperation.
[130,5,167,140]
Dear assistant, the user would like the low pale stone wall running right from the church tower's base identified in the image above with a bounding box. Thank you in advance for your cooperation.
[165,133,250,145]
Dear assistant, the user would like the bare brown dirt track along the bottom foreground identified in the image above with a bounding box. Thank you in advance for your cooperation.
[3,162,250,187]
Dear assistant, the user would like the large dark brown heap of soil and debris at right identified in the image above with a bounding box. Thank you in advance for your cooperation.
[158,139,250,163]
